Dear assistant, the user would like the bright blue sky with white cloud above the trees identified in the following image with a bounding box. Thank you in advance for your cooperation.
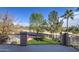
[0,7,78,26]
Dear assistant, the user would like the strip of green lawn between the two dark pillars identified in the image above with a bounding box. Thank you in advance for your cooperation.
[28,38,61,45]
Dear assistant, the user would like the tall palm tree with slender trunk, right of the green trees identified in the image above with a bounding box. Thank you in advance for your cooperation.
[62,10,74,33]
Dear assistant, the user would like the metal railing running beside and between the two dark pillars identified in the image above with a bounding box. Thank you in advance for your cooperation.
[0,32,79,49]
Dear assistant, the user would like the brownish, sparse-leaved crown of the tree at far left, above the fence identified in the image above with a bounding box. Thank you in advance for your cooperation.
[0,13,14,35]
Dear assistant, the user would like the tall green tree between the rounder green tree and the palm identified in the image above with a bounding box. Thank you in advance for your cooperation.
[48,11,58,39]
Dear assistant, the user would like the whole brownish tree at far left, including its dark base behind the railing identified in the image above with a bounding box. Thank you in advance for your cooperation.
[0,13,14,44]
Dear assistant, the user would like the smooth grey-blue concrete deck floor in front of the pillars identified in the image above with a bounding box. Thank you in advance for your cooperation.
[0,45,78,52]
